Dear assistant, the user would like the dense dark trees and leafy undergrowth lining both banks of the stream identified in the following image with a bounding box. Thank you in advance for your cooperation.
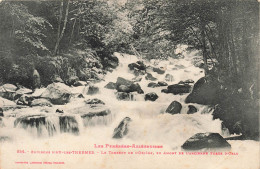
[0,0,259,137]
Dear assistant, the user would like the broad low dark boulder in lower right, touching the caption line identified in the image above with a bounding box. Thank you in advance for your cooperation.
[181,133,231,150]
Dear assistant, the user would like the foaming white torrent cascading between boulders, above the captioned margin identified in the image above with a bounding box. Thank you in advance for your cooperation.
[2,49,228,147]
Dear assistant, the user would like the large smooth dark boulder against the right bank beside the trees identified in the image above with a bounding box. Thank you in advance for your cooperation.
[185,77,221,105]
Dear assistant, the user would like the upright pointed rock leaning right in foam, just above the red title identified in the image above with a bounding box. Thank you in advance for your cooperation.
[113,117,132,139]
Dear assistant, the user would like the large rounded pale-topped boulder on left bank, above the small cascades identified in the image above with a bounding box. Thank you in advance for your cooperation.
[41,83,72,105]
